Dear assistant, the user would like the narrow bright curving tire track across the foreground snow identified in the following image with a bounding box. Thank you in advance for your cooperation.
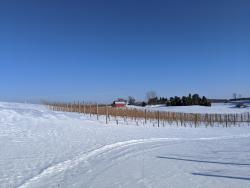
[17,134,250,188]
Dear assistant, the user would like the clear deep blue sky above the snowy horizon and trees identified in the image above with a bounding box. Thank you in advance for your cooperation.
[0,0,250,102]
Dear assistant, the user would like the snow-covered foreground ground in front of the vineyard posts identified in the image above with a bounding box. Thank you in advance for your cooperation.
[0,103,250,188]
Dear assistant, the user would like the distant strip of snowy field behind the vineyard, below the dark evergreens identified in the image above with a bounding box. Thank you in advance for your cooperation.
[128,103,250,114]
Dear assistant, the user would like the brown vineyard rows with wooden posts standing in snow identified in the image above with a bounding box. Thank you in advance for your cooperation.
[46,103,250,127]
